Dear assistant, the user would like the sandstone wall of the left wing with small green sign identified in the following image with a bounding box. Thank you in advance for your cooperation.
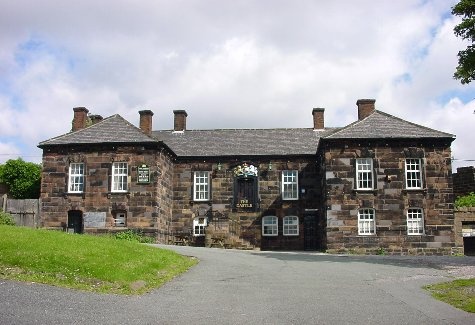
[41,147,173,242]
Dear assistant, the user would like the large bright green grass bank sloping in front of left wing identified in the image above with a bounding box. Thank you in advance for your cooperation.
[0,225,197,294]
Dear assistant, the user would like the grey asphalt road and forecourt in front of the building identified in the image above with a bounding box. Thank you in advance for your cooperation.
[0,246,475,325]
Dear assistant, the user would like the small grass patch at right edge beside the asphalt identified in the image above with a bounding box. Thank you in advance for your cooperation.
[424,279,475,313]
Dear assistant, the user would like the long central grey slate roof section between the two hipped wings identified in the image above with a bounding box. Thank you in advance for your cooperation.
[152,128,334,157]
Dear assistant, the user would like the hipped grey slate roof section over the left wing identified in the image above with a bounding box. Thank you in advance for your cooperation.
[38,114,159,148]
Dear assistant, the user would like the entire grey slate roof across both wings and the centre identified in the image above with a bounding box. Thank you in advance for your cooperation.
[38,110,455,157]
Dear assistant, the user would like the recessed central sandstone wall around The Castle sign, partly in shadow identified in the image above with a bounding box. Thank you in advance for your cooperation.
[173,157,323,249]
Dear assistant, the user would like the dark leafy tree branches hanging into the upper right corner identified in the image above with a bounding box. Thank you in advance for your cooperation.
[452,0,475,84]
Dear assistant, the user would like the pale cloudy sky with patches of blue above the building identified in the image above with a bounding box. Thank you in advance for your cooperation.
[0,0,475,171]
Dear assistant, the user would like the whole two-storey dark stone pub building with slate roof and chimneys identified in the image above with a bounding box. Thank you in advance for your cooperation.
[39,99,455,254]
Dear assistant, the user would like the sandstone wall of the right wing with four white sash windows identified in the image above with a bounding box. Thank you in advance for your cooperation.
[325,143,455,254]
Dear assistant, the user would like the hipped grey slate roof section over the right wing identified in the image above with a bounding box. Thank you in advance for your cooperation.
[325,110,455,140]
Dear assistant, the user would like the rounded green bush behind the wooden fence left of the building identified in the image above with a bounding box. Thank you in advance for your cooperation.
[0,158,41,199]
